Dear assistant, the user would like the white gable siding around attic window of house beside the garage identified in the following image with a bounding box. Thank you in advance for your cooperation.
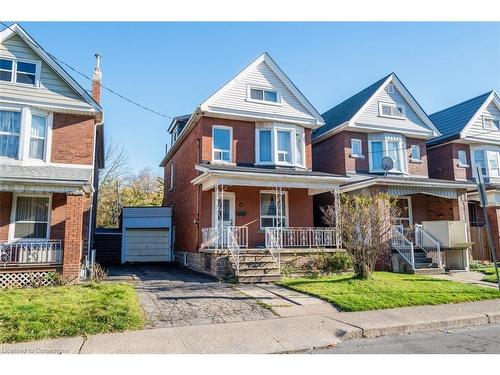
[204,61,314,121]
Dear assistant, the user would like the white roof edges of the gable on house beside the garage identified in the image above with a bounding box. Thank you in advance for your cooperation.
[199,52,324,126]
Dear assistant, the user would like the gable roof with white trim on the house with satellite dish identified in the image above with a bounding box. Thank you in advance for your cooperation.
[313,72,439,140]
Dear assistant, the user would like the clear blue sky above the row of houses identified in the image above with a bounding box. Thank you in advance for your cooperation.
[17,22,500,173]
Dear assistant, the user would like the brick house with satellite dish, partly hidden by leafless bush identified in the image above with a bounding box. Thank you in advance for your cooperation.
[312,73,473,274]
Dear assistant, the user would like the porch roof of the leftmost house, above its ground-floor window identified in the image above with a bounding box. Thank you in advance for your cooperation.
[0,165,93,195]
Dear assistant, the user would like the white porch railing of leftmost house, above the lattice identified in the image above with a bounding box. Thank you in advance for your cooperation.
[0,240,63,267]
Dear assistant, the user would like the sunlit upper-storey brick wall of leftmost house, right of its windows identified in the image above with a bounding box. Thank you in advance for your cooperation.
[51,113,95,165]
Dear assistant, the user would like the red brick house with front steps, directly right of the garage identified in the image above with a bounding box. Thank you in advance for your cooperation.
[161,54,346,281]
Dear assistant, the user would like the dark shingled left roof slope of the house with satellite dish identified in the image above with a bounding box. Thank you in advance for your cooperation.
[313,73,392,137]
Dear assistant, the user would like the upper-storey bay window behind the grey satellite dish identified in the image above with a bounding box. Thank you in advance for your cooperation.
[368,133,406,173]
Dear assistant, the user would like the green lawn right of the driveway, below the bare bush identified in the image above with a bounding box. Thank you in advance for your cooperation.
[278,272,500,311]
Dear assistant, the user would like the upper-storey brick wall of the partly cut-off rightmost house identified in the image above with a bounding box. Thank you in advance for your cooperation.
[427,143,472,180]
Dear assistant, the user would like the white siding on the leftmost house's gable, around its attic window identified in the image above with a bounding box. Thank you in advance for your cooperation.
[0,35,92,110]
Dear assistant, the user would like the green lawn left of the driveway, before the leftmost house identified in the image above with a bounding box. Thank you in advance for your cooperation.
[0,283,144,343]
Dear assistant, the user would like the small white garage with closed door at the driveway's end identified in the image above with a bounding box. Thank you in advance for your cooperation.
[121,207,173,263]
